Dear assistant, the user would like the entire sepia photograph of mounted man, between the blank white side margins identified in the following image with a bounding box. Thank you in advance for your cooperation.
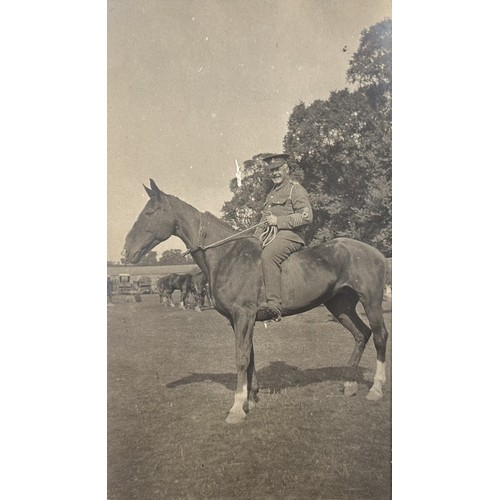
[107,0,392,500]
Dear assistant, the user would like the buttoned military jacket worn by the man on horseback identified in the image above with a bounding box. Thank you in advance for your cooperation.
[254,179,313,243]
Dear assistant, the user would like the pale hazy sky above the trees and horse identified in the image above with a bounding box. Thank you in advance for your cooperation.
[108,0,391,261]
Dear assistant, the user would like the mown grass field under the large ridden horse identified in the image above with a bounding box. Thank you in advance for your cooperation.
[108,295,391,500]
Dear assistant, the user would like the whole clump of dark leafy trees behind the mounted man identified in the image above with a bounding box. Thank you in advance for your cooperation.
[222,20,392,256]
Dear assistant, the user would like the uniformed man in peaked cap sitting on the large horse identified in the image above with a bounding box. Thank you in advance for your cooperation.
[254,154,313,321]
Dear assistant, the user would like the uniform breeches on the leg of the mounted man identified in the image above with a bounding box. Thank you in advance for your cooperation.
[262,238,304,311]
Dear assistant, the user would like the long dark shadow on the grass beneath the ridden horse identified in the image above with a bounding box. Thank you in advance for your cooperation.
[166,361,370,394]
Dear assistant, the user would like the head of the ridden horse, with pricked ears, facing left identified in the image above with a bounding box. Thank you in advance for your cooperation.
[122,179,175,264]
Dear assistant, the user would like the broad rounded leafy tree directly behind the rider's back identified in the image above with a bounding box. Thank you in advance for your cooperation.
[285,90,391,253]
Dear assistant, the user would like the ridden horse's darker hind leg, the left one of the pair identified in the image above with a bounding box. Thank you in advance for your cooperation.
[325,291,372,396]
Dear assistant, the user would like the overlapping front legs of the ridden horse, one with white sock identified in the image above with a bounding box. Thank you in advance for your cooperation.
[226,310,257,424]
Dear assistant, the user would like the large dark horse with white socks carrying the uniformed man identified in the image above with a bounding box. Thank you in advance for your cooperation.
[123,179,388,423]
